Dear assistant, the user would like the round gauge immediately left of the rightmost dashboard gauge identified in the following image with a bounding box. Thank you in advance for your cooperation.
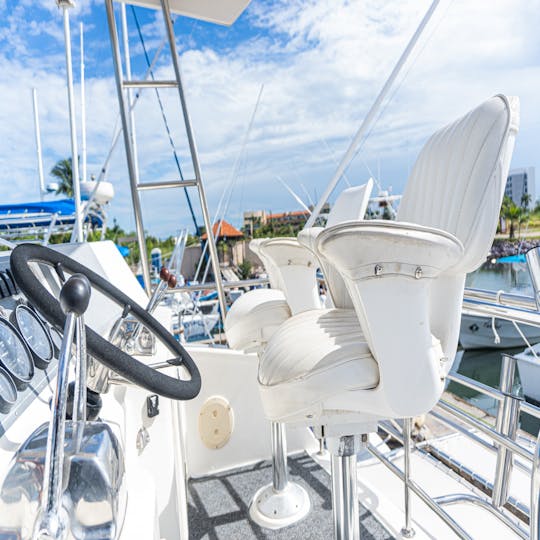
[0,319,34,390]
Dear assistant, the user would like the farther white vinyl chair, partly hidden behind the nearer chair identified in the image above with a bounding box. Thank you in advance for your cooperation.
[225,180,373,352]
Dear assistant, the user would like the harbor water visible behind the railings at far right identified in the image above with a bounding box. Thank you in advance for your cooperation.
[448,263,540,436]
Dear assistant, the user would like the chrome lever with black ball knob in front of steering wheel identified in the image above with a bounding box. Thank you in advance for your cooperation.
[33,274,91,540]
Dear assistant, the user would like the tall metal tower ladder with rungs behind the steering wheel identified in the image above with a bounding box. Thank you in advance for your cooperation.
[105,0,227,318]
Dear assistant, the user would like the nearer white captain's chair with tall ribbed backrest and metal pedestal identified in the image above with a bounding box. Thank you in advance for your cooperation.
[259,95,519,539]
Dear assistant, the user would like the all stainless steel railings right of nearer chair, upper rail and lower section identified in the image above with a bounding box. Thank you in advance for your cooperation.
[368,289,540,540]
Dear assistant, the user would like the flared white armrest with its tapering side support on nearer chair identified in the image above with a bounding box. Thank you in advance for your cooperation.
[316,221,463,418]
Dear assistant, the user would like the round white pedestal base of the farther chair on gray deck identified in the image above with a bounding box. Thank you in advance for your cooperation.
[249,482,311,529]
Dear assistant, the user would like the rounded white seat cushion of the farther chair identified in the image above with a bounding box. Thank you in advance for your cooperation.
[225,289,291,351]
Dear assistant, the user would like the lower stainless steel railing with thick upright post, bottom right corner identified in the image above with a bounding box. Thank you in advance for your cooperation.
[368,348,540,540]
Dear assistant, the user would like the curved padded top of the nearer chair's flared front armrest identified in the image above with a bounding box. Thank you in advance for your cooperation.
[314,220,464,280]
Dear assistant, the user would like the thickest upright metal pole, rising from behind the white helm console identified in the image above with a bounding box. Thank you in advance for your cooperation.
[56,0,83,242]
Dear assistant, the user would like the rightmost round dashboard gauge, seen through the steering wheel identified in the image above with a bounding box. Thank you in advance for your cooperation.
[10,304,54,369]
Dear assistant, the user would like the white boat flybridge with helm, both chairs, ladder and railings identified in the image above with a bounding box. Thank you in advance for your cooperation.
[0,0,540,540]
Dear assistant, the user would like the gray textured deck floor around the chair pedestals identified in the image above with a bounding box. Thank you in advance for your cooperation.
[188,454,393,540]
